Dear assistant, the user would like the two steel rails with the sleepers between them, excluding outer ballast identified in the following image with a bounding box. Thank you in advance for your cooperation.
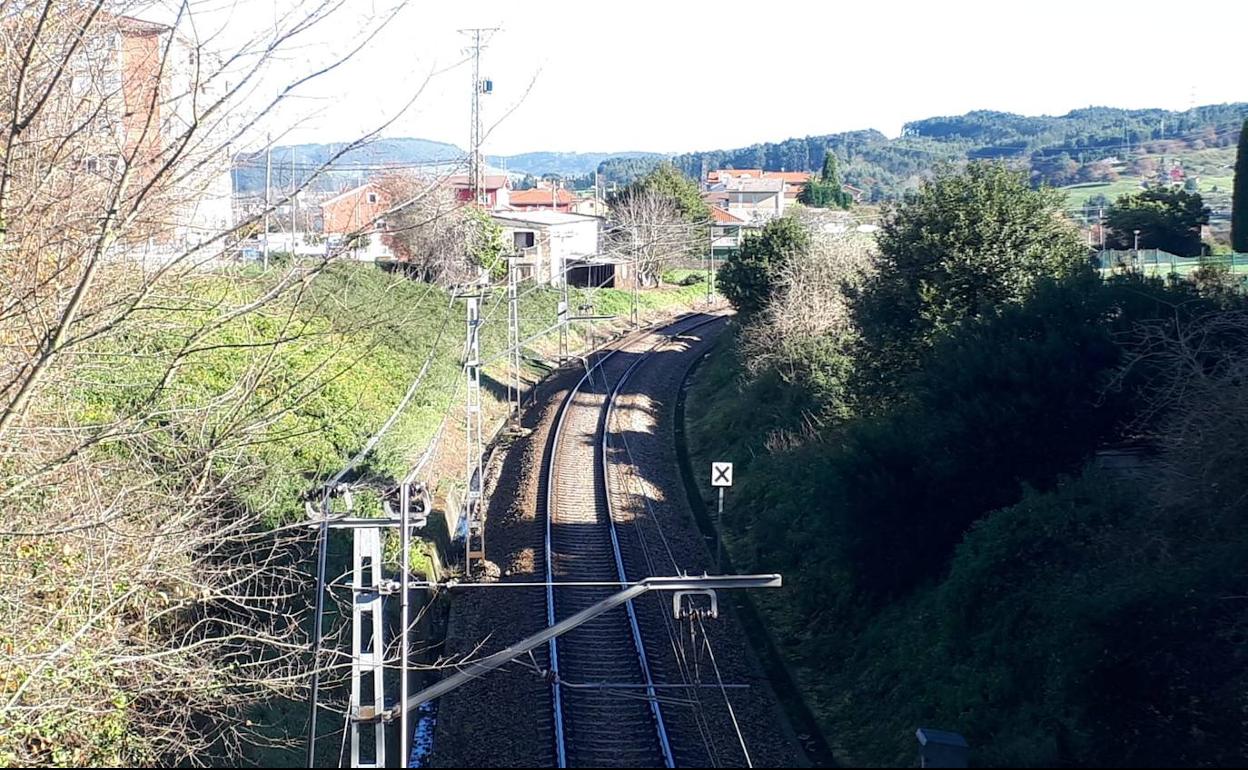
[544,314,715,768]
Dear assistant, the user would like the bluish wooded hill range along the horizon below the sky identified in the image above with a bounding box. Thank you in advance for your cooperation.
[235,102,1248,201]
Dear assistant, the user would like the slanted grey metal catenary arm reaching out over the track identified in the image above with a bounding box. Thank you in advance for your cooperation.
[402,575,781,711]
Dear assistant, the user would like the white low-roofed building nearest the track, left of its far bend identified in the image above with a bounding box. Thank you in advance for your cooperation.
[492,210,600,286]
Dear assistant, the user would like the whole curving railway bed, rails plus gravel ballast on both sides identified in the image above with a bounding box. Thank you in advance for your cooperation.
[433,309,801,768]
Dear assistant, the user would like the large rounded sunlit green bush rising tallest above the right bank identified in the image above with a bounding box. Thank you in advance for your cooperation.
[854,163,1090,389]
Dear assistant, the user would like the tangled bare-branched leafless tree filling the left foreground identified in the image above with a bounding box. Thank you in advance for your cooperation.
[0,0,469,765]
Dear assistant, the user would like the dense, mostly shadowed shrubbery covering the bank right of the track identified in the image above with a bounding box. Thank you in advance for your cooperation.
[690,160,1248,765]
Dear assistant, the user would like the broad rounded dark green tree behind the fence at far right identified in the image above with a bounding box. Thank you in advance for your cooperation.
[1106,187,1209,257]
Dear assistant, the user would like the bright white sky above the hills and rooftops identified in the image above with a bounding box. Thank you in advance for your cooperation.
[160,0,1248,155]
